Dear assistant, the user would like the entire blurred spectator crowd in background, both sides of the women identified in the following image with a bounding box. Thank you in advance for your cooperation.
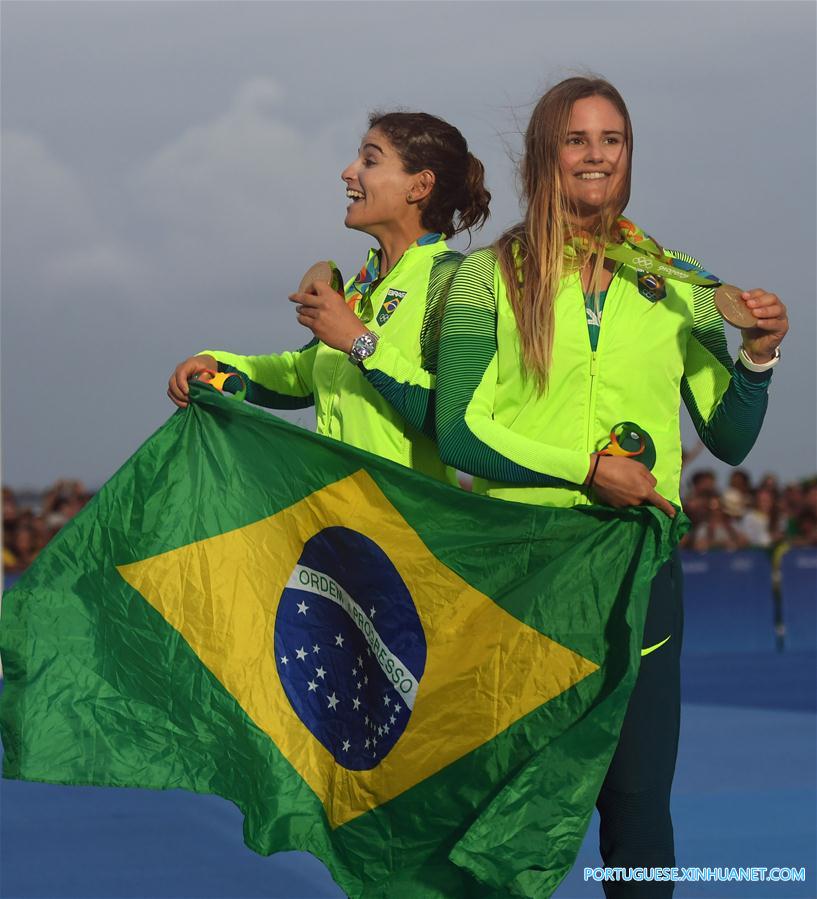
[3,469,817,574]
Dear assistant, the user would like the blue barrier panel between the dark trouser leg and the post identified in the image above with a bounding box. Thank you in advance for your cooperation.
[681,550,775,654]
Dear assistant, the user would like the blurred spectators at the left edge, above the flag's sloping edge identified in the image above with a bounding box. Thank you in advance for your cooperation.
[3,480,91,574]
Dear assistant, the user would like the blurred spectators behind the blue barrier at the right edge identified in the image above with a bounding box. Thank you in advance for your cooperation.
[681,469,817,552]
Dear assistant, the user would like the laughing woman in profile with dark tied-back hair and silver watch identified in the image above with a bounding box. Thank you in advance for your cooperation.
[168,112,491,483]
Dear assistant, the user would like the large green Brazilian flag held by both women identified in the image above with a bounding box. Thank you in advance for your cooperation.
[0,384,681,899]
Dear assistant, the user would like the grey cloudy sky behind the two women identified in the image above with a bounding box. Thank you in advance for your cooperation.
[0,0,817,489]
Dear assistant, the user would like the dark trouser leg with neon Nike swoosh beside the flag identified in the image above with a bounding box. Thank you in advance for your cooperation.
[596,552,683,899]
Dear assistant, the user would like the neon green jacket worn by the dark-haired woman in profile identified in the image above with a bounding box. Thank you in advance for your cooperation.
[202,235,463,483]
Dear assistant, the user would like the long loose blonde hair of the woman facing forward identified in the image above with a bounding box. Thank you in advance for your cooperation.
[494,77,633,393]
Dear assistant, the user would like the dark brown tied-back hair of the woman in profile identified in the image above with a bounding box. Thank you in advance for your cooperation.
[369,112,491,237]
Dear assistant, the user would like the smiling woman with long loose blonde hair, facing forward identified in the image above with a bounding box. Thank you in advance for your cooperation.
[437,78,788,899]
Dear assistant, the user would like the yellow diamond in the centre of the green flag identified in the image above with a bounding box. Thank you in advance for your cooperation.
[118,470,598,827]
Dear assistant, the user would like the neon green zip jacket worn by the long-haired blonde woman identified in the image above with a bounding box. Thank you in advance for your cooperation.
[437,250,771,506]
